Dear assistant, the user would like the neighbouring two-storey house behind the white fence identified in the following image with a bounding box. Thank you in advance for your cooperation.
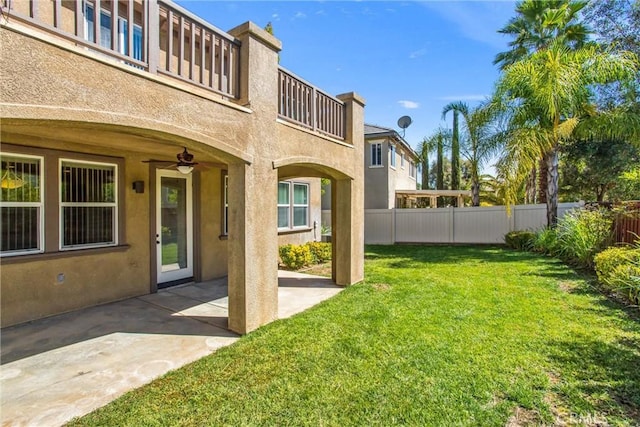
[322,124,419,214]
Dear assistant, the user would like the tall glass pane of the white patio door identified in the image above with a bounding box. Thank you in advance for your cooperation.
[160,177,187,272]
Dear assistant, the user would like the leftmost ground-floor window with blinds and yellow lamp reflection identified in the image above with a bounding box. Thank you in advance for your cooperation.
[0,153,43,256]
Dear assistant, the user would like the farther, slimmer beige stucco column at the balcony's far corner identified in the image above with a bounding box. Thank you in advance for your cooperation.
[331,93,364,285]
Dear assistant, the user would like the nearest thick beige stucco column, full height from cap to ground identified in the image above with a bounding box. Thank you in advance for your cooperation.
[228,22,281,334]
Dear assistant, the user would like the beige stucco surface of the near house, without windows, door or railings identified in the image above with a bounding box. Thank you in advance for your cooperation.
[0,17,363,332]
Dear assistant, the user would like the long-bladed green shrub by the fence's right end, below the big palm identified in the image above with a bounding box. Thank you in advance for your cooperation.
[556,209,613,268]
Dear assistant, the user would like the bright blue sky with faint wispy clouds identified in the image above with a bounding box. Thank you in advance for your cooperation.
[178,0,515,155]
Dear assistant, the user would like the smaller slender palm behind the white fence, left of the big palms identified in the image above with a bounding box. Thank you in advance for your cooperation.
[442,102,502,206]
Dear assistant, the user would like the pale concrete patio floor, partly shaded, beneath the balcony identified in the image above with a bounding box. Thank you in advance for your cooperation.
[0,271,342,426]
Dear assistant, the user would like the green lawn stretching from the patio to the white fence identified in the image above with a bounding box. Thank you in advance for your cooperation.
[72,246,640,426]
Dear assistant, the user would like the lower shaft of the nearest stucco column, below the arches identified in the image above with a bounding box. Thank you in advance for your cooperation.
[228,160,278,334]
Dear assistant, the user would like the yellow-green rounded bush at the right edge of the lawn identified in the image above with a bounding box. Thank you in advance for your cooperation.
[594,247,640,305]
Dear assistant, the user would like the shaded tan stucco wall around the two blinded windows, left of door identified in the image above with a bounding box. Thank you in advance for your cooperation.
[0,142,150,327]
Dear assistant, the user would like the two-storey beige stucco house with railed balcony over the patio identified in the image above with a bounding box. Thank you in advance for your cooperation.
[0,0,365,333]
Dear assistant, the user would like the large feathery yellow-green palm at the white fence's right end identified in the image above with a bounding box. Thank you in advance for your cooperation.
[493,40,638,226]
